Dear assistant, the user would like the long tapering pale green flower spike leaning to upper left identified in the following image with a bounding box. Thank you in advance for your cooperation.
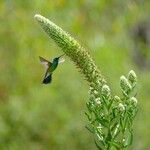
[34,15,106,88]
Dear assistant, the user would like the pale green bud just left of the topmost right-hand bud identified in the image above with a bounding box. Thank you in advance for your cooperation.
[120,76,132,92]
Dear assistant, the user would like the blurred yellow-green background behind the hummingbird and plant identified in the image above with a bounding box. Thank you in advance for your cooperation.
[0,0,150,150]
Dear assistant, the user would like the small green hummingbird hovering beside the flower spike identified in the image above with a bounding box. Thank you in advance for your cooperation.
[39,54,65,84]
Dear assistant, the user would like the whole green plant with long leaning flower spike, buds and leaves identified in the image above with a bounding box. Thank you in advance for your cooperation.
[35,15,138,150]
